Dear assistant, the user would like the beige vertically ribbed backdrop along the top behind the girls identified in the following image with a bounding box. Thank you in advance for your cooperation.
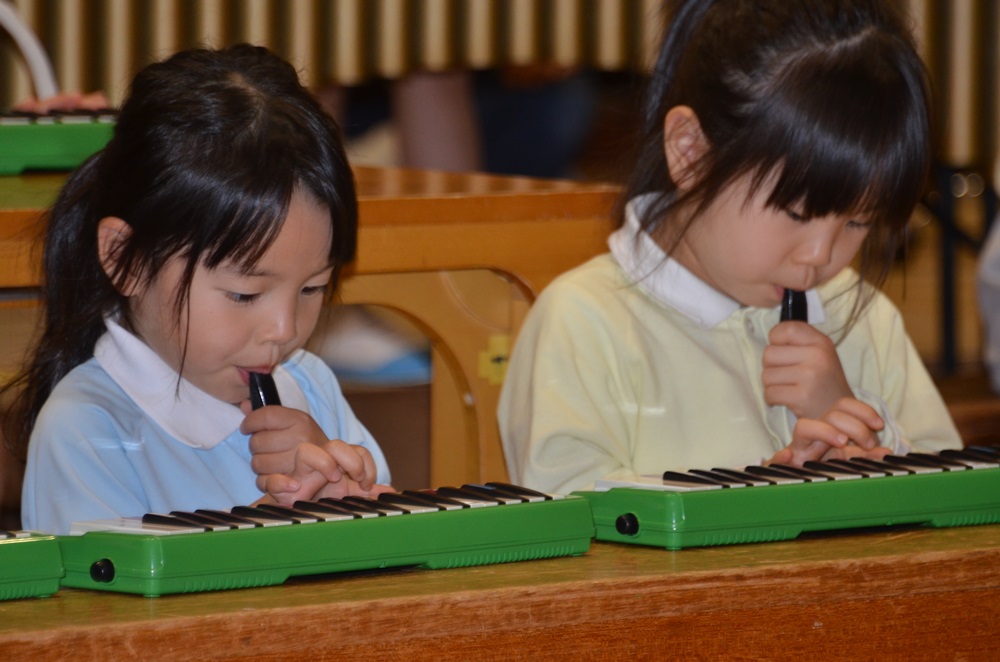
[0,0,1000,178]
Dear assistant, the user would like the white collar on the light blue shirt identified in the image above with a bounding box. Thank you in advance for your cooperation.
[94,319,309,449]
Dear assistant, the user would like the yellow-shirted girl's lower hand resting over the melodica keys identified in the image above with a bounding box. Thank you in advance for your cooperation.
[770,398,890,467]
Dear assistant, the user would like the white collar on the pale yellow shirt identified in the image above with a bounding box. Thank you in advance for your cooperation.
[608,193,826,329]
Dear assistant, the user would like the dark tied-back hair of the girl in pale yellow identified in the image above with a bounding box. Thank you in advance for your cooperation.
[616,0,931,314]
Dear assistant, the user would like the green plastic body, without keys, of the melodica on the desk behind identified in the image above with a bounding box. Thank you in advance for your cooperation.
[0,121,114,175]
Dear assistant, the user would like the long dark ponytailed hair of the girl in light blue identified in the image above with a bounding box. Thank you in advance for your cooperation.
[3,44,357,460]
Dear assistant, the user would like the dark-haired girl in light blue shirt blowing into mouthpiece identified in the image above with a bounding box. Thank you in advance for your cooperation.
[0,45,389,533]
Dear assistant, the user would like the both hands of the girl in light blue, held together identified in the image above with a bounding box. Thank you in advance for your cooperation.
[240,402,378,504]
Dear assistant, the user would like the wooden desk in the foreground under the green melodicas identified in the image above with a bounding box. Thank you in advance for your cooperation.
[0,526,1000,660]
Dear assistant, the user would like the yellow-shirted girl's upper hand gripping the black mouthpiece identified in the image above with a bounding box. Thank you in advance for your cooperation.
[761,322,852,419]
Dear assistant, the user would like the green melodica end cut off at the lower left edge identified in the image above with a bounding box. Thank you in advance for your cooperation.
[0,534,63,600]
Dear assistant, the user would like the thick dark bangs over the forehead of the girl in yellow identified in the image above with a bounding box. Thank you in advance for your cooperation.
[742,33,930,226]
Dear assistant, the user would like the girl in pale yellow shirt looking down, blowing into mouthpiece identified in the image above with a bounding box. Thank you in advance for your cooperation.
[499,0,960,492]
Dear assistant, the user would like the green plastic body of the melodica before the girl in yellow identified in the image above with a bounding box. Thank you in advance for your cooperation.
[574,468,1000,549]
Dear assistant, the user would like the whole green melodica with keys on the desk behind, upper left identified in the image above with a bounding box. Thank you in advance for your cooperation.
[0,110,115,175]
